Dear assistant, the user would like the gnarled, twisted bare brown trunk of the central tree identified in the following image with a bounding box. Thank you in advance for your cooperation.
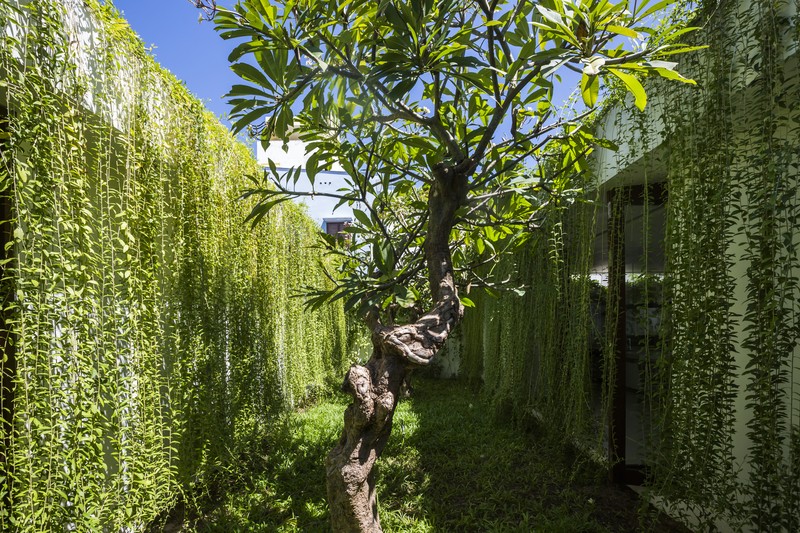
[325,168,466,533]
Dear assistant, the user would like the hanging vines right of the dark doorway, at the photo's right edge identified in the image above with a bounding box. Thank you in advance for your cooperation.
[651,0,800,531]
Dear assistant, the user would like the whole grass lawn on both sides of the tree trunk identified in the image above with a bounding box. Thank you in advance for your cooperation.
[175,381,674,533]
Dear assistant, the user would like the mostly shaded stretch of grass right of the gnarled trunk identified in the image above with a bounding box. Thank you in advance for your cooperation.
[378,379,686,533]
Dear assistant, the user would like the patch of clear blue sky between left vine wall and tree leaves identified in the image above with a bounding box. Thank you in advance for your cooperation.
[107,0,239,124]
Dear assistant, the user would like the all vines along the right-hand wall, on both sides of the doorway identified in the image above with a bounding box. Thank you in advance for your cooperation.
[461,0,800,531]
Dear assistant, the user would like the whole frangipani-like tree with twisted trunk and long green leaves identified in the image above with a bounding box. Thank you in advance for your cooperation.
[193,0,691,532]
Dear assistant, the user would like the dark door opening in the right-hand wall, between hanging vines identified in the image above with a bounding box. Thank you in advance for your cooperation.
[598,183,667,485]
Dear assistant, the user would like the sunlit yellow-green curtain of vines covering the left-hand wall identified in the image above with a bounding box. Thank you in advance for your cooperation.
[0,0,348,531]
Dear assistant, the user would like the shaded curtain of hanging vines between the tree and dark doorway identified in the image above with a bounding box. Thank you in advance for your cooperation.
[462,187,601,446]
